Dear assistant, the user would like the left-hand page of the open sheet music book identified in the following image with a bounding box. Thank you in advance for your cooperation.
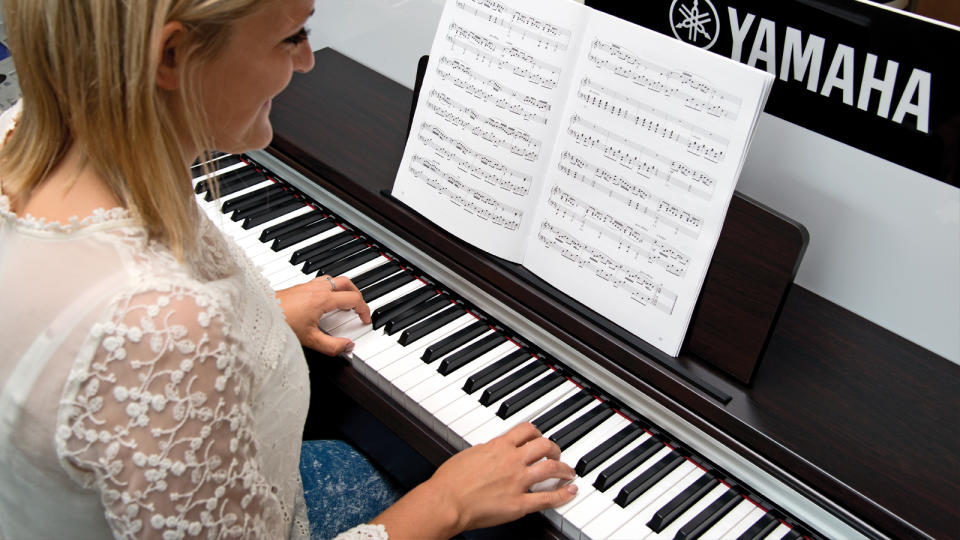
[393,0,589,262]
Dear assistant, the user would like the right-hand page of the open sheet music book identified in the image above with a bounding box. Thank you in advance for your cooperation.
[523,11,772,356]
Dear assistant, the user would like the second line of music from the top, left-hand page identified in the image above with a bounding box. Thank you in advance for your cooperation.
[446,23,560,89]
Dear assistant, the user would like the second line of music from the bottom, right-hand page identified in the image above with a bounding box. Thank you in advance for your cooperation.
[547,186,690,277]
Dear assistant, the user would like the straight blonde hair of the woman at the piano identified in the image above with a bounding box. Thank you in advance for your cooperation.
[0,0,266,260]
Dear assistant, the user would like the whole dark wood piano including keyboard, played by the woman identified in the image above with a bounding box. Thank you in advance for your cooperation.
[198,49,960,538]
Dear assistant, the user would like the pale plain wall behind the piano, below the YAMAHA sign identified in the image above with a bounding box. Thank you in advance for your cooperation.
[310,0,960,363]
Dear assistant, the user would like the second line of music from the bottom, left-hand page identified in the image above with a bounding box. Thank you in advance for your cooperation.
[417,123,533,196]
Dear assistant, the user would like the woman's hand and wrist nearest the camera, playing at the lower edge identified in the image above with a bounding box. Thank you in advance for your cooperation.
[373,423,576,538]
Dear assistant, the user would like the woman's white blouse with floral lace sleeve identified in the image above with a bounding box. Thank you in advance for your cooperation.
[0,104,385,539]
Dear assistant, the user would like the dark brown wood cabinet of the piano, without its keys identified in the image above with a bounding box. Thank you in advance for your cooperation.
[267,49,960,538]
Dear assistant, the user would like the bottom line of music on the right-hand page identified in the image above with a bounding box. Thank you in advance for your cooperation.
[537,221,677,315]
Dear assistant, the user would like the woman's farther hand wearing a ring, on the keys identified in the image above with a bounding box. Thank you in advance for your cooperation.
[276,276,370,356]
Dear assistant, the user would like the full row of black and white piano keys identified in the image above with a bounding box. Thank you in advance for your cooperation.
[194,155,860,539]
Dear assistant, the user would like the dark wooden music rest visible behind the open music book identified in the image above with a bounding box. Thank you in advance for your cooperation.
[406,55,809,384]
